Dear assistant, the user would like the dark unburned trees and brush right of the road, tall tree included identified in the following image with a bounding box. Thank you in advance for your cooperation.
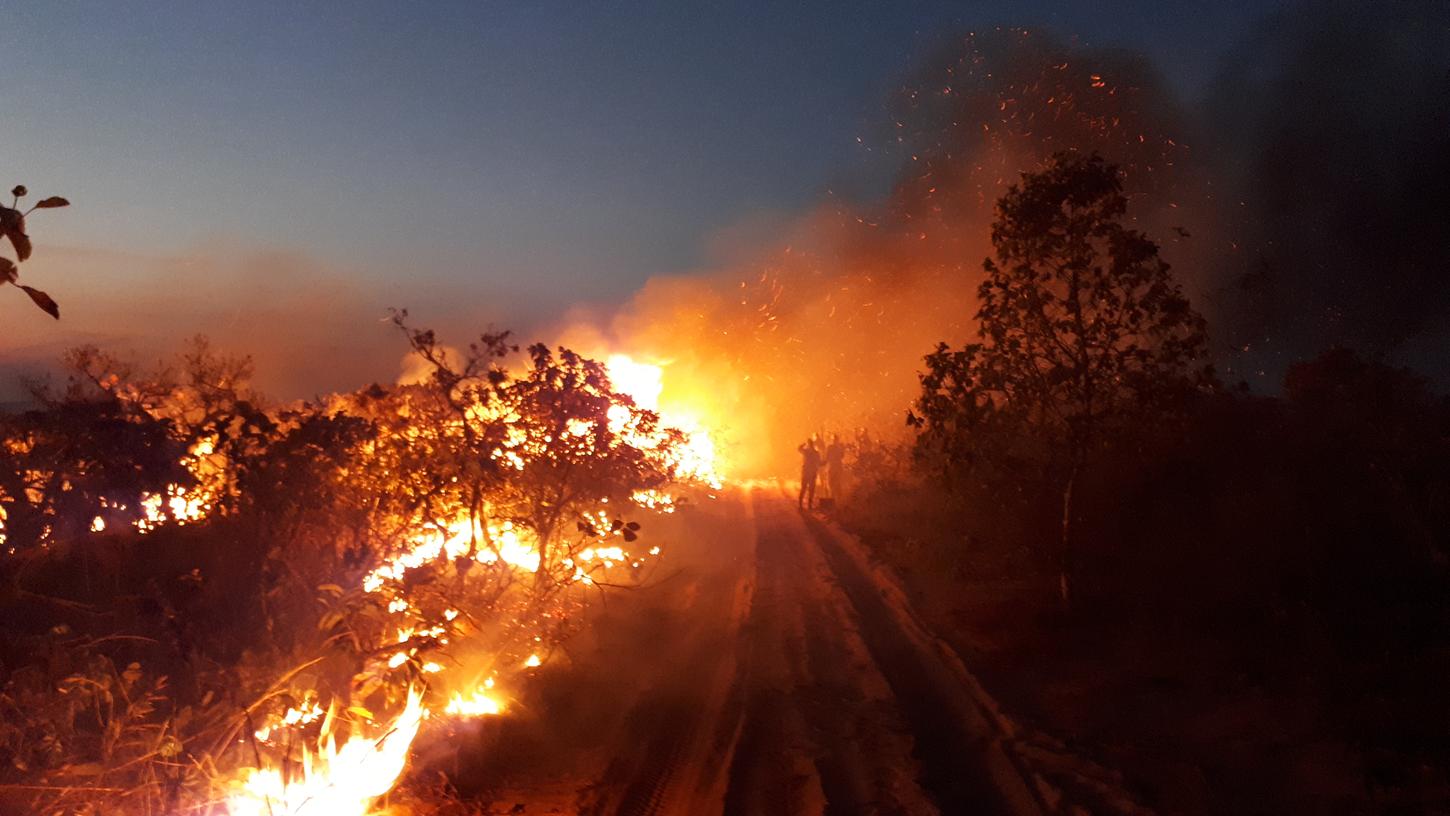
[841,155,1450,813]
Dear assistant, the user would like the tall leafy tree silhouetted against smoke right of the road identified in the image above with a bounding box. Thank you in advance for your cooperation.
[909,152,1212,606]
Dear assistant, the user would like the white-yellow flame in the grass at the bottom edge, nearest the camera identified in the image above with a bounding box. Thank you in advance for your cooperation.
[226,687,426,816]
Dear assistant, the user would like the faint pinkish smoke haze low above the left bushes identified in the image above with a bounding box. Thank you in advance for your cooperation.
[0,246,400,400]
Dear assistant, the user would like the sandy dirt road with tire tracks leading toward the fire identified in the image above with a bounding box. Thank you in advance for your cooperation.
[577,490,1037,816]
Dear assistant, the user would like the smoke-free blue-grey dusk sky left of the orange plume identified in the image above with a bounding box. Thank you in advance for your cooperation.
[8,0,1269,397]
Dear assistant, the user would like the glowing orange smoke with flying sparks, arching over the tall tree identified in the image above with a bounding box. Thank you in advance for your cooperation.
[563,29,1208,475]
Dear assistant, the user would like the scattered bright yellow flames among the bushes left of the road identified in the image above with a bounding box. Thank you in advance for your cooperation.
[0,342,721,816]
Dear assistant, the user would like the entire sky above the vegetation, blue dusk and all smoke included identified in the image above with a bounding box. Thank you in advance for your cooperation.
[0,0,1450,414]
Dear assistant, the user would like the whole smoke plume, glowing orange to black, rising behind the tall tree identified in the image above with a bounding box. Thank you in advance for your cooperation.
[566,3,1450,475]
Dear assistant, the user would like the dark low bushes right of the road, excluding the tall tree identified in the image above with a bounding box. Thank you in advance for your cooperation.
[845,349,1450,813]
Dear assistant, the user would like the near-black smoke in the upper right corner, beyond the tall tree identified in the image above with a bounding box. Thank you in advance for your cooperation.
[1205,1,1450,377]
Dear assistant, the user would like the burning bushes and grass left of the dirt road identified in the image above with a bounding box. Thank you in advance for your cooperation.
[0,313,709,816]
